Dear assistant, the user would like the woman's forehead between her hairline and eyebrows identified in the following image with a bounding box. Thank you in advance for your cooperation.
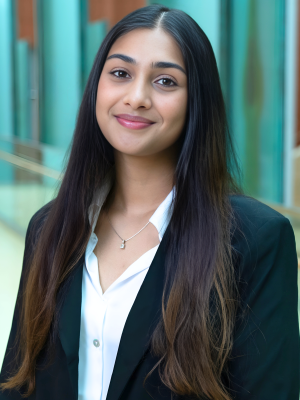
[108,28,184,67]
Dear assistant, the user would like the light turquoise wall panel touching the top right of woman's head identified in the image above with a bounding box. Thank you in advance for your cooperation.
[148,0,221,65]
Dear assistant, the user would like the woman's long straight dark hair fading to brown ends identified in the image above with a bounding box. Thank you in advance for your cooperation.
[2,5,238,400]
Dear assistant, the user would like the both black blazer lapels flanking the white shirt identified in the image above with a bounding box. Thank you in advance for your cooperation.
[59,227,169,400]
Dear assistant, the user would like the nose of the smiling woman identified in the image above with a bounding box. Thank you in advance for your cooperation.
[123,77,152,110]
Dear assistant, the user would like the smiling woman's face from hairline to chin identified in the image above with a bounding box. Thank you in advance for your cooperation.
[96,29,187,156]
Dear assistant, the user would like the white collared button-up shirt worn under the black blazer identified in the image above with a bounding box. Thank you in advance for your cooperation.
[78,174,174,400]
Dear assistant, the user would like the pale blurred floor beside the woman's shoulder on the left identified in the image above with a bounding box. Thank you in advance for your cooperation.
[0,182,57,366]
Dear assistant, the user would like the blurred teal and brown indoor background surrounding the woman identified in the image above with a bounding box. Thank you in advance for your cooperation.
[0,0,300,374]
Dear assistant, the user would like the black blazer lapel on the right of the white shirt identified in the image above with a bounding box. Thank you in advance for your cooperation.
[106,229,169,400]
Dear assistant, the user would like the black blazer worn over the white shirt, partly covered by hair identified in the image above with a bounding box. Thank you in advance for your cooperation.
[0,196,300,400]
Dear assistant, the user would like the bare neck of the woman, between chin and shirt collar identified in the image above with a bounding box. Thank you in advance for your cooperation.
[111,149,177,215]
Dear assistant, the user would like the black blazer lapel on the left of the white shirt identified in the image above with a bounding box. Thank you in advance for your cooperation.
[59,257,84,399]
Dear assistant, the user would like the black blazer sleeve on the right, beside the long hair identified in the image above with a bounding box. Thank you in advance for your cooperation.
[227,214,300,400]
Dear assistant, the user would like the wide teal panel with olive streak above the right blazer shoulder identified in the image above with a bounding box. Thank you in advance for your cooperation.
[229,0,284,202]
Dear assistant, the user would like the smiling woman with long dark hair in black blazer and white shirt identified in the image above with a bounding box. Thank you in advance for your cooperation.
[0,5,299,400]
